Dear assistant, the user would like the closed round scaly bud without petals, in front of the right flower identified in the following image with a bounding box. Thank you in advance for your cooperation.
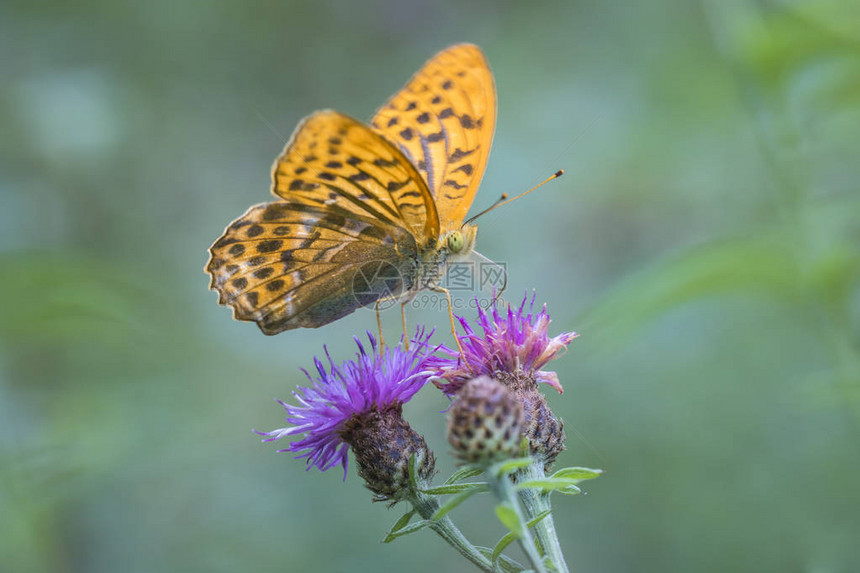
[448,376,524,462]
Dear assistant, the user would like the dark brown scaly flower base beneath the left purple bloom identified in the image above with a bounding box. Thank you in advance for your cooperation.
[338,404,436,501]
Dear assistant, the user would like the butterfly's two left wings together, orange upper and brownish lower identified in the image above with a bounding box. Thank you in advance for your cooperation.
[206,111,439,334]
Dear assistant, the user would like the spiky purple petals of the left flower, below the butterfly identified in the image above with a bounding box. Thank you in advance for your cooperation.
[255,329,434,479]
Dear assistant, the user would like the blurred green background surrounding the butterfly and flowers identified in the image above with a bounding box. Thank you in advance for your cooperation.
[0,0,860,573]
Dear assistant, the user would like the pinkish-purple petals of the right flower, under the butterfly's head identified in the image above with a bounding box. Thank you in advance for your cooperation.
[427,293,579,396]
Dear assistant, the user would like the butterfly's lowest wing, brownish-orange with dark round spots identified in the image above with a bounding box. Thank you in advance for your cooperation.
[206,201,416,334]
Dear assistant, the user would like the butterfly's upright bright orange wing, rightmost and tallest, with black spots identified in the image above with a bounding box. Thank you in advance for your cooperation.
[371,44,496,229]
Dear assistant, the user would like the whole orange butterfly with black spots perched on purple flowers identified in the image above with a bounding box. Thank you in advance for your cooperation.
[206,44,496,335]
